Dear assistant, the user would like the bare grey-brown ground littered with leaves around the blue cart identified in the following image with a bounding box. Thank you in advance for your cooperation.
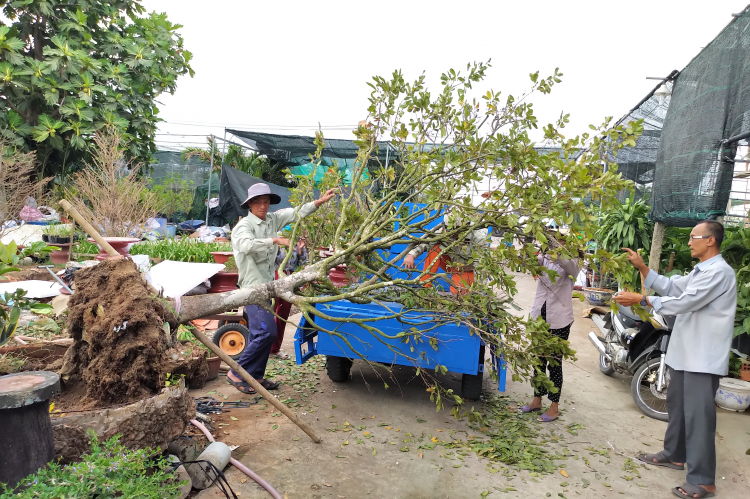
[193,275,750,499]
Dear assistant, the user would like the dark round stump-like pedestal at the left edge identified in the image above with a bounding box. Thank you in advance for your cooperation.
[0,371,60,486]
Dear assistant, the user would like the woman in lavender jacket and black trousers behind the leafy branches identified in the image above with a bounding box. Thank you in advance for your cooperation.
[519,250,581,423]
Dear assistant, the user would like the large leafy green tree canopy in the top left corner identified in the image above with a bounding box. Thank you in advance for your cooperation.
[0,0,193,176]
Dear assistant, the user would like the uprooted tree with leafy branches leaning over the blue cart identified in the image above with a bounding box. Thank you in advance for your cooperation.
[173,63,641,406]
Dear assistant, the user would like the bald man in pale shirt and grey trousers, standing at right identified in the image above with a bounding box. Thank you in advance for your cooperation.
[614,220,737,497]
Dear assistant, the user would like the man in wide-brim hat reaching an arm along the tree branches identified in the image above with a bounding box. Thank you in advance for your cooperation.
[227,184,337,394]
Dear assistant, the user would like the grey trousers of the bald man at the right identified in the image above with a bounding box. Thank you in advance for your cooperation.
[664,367,721,485]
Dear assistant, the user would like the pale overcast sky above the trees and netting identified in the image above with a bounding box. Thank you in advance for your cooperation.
[143,0,746,148]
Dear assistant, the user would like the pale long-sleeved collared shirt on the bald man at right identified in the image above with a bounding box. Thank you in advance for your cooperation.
[644,255,737,376]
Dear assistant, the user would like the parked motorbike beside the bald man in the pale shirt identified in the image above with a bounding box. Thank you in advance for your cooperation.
[589,306,675,421]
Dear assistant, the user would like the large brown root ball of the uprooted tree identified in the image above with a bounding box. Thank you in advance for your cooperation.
[60,259,203,405]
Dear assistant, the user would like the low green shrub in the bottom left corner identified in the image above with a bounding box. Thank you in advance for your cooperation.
[0,430,187,499]
